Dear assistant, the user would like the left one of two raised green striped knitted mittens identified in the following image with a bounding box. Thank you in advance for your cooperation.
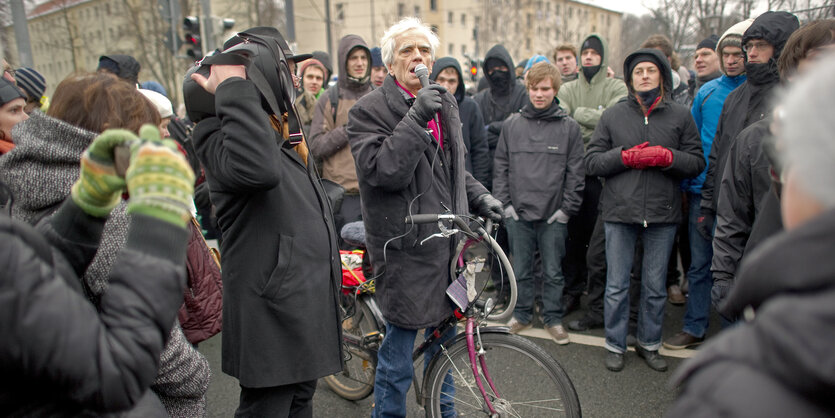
[71,129,139,218]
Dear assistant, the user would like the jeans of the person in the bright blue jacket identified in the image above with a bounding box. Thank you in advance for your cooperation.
[683,193,713,338]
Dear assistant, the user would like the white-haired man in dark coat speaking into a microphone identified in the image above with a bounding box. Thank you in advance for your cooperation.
[347,18,502,417]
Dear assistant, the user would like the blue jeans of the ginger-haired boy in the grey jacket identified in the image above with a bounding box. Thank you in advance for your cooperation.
[506,219,568,327]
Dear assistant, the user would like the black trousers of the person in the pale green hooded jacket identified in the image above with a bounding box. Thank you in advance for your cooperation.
[562,176,605,298]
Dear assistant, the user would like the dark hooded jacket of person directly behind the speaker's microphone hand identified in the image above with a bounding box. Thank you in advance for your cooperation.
[429,57,493,184]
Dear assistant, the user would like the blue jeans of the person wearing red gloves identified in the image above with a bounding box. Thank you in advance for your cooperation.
[603,222,676,353]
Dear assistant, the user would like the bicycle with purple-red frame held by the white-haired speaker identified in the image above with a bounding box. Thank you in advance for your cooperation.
[325,214,581,417]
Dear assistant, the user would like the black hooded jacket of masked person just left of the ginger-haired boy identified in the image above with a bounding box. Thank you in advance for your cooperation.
[473,45,528,188]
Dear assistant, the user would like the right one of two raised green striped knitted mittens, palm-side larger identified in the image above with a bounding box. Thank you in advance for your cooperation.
[125,125,194,228]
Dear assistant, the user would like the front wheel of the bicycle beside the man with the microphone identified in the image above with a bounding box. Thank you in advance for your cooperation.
[424,333,581,417]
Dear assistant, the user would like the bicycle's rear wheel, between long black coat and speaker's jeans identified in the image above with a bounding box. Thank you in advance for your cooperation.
[323,295,383,401]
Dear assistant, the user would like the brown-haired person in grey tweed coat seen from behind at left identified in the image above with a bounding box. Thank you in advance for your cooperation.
[0,73,210,417]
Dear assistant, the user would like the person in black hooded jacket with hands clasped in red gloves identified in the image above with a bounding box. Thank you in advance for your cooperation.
[584,48,705,372]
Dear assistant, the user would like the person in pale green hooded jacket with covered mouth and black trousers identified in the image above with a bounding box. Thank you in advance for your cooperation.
[557,34,626,331]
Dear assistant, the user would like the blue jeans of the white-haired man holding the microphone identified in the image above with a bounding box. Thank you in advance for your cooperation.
[371,324,456,418]
